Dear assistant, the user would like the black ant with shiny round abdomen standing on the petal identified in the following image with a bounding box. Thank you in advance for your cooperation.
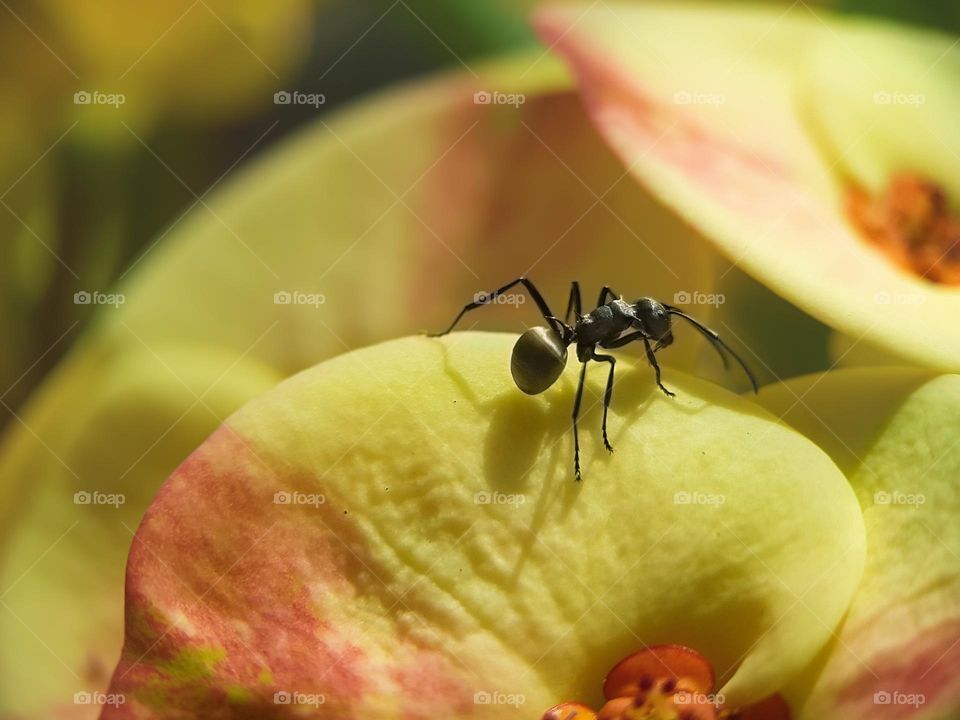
[429,277,757,481]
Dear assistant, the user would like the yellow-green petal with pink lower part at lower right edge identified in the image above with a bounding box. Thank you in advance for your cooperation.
[760,368,960,720]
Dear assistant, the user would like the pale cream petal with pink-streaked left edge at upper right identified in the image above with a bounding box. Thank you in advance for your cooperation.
[537,5,960,369]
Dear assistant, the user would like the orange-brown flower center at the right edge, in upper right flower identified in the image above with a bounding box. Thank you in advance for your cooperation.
[846,172,960,285]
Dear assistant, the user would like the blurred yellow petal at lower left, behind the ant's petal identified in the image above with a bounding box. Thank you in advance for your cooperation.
[0,346,278,718]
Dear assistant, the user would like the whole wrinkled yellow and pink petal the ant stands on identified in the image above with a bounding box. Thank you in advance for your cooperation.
[103,333,863,720]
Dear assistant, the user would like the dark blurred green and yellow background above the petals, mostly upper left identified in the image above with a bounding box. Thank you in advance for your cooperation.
[0,0,960,425]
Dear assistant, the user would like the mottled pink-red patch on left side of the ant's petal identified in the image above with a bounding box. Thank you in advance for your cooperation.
[104,426,470,720]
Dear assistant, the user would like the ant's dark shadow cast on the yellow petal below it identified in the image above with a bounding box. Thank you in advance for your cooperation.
[436,348,699,585]
